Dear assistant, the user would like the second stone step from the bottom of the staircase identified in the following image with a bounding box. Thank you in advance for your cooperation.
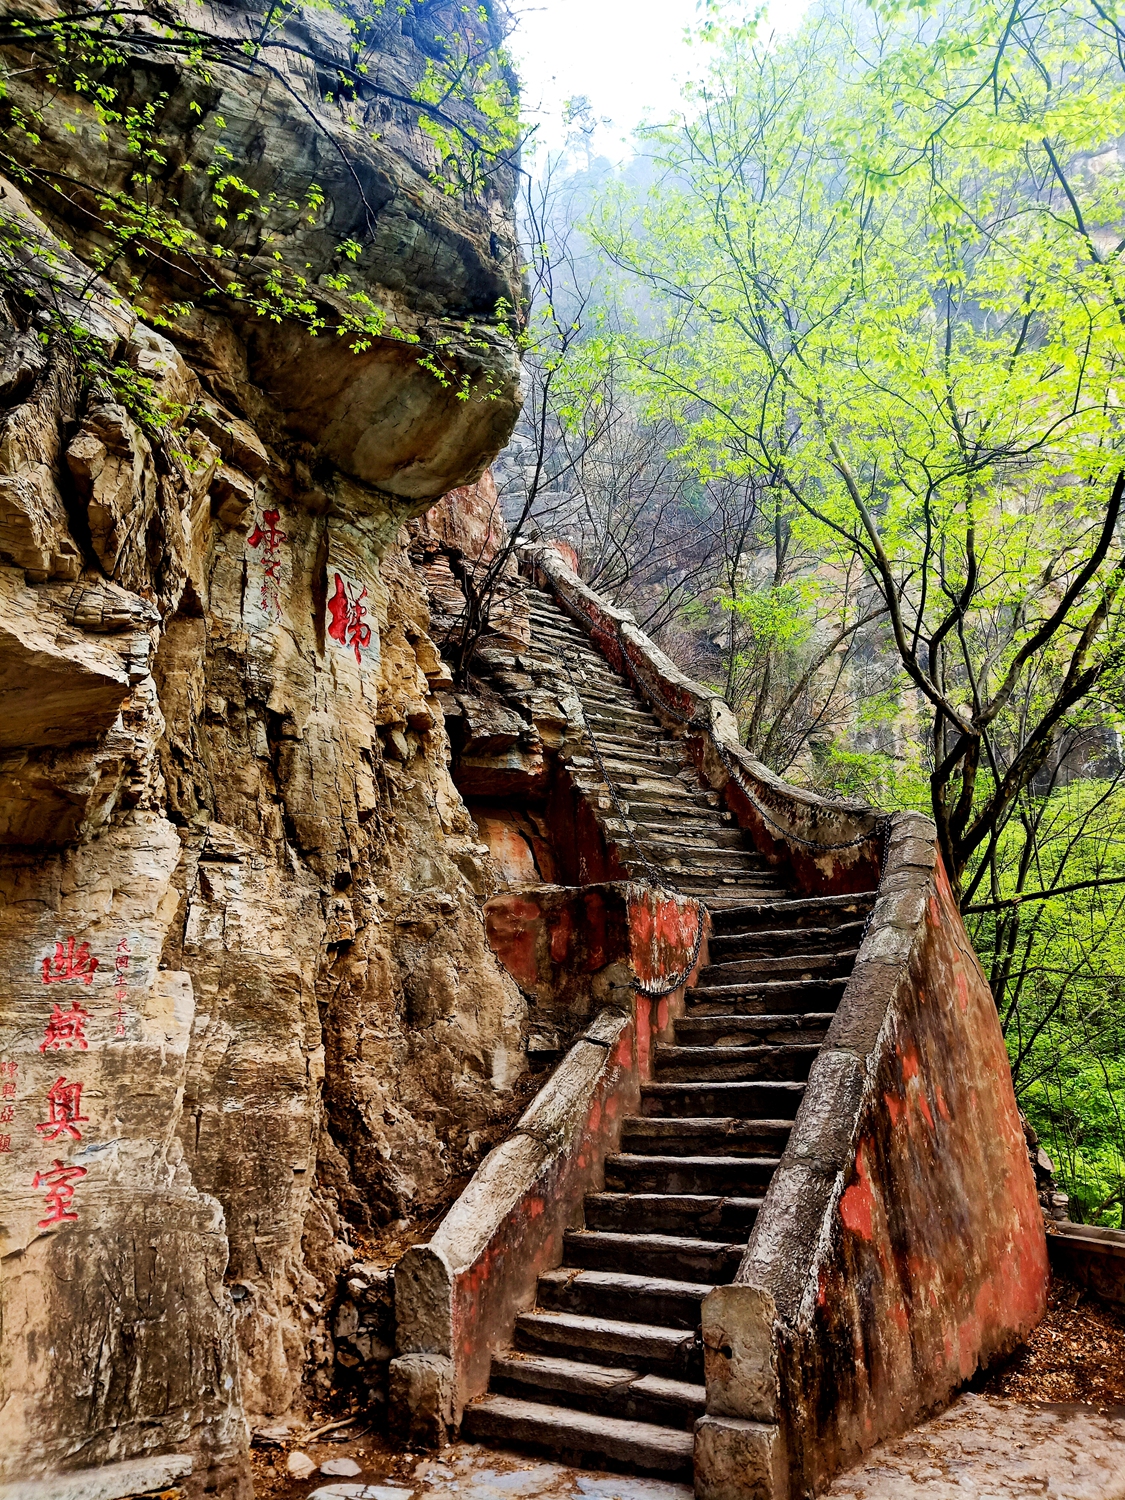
[491,1355,707,1430]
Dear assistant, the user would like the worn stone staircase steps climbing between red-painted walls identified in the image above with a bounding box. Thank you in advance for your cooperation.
[464,587,875,1479]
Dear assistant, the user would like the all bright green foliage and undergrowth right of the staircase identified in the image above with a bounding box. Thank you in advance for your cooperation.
[576,0,1125,1218]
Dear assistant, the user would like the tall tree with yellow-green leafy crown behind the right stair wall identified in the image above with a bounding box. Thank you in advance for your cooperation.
[596,3,1125,900]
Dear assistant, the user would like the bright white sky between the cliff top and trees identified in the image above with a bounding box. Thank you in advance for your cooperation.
[510,0,809,161]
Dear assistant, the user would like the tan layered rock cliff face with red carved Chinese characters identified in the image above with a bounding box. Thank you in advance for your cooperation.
[0,6,525,1493]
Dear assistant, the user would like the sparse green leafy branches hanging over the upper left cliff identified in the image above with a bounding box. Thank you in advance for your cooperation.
[0,0,518,411]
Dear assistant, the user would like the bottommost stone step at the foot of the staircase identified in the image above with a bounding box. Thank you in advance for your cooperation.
[462,1394,695,1479]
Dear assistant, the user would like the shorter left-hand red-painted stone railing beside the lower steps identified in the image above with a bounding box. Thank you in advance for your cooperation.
[390,884,707,1448]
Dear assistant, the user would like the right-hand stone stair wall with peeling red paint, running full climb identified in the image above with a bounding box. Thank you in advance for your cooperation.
[522,546,1047,1500]
